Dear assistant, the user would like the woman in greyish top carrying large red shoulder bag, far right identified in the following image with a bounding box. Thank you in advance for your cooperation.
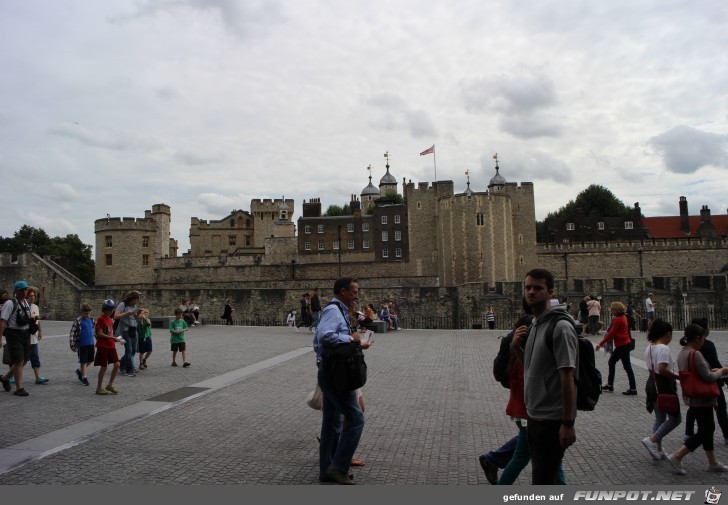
[664,323,728,475]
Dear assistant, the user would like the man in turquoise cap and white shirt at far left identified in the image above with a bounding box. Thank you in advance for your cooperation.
[0,281,32,396]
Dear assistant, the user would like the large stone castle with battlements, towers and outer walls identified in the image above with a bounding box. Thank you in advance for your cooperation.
[0,155,728,327]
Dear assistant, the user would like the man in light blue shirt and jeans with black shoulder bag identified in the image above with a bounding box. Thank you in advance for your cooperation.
[313,277,369,484]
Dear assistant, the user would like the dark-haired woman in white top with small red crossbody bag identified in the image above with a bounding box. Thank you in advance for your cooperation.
[642,319,681,461]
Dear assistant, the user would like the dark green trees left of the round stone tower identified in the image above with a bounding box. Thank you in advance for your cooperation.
[0,225,95,285]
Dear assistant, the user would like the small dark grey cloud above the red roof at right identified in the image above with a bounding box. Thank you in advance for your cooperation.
[648,125,728,174]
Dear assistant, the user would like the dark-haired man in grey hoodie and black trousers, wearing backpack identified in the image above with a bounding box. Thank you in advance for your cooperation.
[511,268,578,485]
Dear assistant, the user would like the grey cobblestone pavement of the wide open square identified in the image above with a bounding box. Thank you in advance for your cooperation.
[0,321,728,485]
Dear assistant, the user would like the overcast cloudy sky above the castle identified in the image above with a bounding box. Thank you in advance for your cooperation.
[0,0,728,251]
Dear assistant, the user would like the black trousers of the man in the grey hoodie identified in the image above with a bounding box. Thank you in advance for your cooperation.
[528,419,564,485]
